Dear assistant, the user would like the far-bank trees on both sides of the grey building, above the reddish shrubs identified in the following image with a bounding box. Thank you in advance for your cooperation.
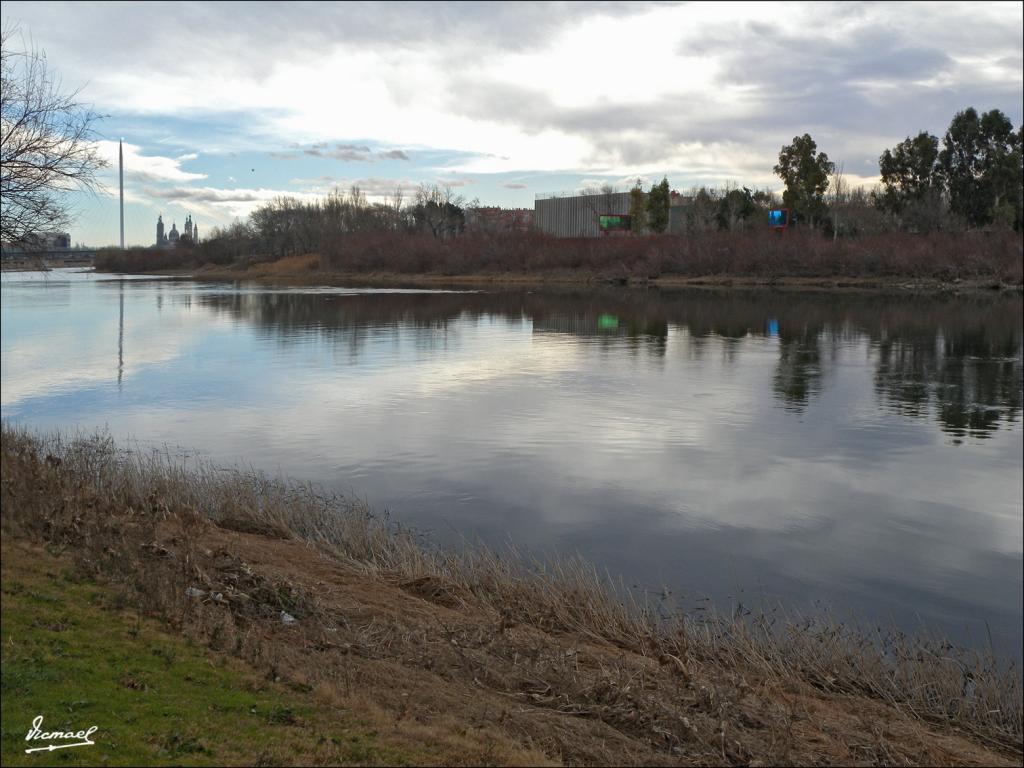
[196,100,1024,263]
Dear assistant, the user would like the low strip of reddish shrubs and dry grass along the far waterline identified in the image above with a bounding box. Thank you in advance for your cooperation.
[96,230,1024,290]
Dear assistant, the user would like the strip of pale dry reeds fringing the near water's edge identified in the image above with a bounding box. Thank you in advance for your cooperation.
[0,423,1022,752]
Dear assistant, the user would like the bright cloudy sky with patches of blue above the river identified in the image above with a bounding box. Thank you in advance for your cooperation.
[3,2,1024,245]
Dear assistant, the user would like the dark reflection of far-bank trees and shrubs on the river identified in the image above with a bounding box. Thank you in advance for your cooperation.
[188,284,1022,437]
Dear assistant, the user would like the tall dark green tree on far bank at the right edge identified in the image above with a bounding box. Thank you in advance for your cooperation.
[939,106,1024,228]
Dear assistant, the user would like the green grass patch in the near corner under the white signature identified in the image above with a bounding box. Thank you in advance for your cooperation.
[0,542,419,766]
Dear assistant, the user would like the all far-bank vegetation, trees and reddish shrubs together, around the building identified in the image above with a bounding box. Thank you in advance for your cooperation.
[95,108,1024,290]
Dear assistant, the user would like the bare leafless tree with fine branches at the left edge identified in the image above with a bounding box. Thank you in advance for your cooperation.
[0,26,108,246]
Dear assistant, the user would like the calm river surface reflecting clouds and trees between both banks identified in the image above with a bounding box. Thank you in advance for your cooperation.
[2,271,1024,658]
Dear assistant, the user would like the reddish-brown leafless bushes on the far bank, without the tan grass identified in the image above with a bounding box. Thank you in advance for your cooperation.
[96,230,1024,285]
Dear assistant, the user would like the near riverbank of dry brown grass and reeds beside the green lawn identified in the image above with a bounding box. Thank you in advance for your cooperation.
[0,425,1022,765]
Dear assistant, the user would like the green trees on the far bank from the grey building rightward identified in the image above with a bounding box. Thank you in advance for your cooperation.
[552,108,1024,239]
